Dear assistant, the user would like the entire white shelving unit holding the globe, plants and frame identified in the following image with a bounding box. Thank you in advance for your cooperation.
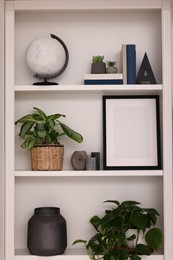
[5,0,173,260]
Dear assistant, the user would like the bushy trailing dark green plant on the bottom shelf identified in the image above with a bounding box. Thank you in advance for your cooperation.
[73,200,163,260]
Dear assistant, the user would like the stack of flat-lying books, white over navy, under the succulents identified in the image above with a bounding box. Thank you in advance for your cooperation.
[84,73,123,85]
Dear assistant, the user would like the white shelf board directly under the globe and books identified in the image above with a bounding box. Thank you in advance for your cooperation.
[15,84,163,93]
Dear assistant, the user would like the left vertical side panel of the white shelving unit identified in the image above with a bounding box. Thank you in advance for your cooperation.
[5,2,14,260]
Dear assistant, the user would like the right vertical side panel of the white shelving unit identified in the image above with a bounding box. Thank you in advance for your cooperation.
[162,4,173,260]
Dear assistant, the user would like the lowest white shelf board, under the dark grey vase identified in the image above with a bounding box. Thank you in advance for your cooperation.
[14,249,163,260]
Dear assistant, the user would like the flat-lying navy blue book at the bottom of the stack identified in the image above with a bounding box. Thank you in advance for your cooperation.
[84,79,123,85]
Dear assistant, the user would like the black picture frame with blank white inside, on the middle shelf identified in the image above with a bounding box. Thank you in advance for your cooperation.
[103,95,161,170]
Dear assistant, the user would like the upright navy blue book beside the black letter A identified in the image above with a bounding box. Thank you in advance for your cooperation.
[126,44,136,84]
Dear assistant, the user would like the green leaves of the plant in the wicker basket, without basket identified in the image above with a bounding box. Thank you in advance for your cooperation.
[15,107,83,150]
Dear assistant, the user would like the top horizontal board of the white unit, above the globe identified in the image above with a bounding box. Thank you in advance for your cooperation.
[7,0,163,11]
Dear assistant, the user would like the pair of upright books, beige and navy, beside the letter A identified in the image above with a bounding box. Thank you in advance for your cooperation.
[122,44,136,84]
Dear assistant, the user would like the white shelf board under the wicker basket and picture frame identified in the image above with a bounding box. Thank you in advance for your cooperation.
[15,170,163,177]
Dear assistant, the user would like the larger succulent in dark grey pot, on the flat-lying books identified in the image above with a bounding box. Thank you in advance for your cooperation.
[91,55,106,74]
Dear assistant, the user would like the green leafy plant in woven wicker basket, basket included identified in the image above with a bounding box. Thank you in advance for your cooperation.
[15,107,83,170]
